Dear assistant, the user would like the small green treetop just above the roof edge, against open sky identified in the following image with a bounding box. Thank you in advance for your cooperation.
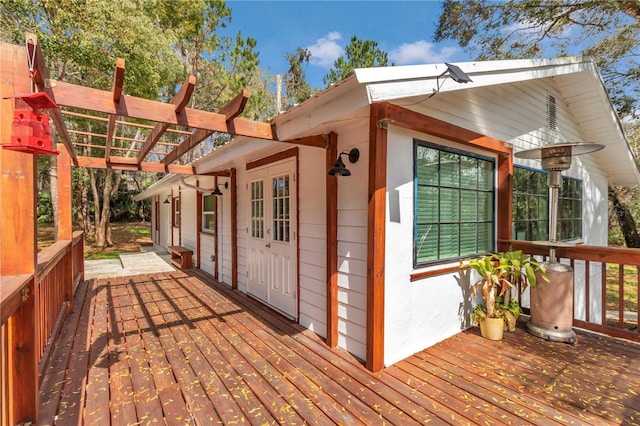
[322,36,393,86]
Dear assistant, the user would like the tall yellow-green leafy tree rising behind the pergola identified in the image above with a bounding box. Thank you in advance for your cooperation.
[0,0,258,247]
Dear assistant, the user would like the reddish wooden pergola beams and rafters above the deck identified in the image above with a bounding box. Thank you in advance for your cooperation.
[27,34,278,174]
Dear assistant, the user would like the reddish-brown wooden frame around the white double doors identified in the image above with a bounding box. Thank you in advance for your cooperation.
[245,146,300,322]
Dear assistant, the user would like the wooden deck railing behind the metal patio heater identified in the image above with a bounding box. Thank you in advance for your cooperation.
[499,240,640,341]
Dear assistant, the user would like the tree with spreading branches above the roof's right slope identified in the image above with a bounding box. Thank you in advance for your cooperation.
[434,0,640,247]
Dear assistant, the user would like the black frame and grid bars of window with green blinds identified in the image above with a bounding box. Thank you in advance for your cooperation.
[412,138,497,269]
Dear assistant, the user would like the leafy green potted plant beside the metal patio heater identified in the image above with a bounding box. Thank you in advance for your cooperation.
[461,250,548,340]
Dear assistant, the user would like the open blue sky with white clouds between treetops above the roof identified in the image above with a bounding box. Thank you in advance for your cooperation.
[227,0,472,88]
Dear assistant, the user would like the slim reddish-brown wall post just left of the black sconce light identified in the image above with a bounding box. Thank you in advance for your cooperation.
[325,132,338,348]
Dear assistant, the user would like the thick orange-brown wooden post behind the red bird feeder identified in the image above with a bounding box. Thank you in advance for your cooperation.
[0,43,39,424]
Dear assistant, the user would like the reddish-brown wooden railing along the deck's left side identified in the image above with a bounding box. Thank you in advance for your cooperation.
[0,232,84,425]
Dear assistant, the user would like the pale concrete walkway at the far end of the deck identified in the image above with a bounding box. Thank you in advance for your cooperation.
[84,246,176,280]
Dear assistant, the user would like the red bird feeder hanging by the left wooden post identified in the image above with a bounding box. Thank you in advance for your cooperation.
[2,92,59,155]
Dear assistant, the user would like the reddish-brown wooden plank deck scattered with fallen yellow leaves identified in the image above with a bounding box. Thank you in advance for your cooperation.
[39,270,640,425]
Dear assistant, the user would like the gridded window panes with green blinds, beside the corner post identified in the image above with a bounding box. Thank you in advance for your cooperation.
[414,140,495,267]
